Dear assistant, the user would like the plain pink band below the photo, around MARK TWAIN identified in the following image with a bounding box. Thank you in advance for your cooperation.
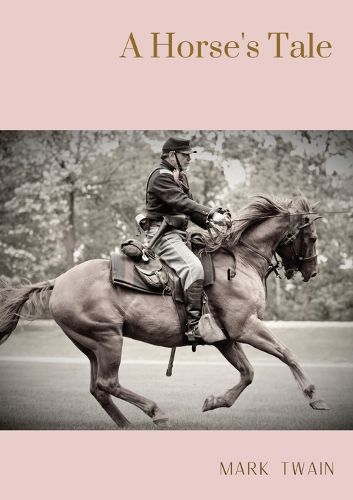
[0,431,351,500]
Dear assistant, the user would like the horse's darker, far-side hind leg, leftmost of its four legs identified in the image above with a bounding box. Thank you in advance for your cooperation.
[71,338,130,427]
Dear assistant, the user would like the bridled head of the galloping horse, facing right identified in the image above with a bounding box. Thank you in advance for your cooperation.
[276,198,320,281]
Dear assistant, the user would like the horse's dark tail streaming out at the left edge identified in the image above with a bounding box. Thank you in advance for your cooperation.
[0,280,54,344]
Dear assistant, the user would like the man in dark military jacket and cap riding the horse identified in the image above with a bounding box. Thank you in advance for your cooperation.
[146,137,230,342]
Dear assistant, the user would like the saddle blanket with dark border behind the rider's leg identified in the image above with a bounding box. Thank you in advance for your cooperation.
[111,253,171,295]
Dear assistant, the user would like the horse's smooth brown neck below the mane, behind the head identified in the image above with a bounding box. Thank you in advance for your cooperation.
[239,218,288,275]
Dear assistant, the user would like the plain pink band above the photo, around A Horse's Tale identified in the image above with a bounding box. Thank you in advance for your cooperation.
[0,0,353,130]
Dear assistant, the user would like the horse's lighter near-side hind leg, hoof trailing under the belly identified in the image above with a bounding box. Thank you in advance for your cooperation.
[95,332,168,428]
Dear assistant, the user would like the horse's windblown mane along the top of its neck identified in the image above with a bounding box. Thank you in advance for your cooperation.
[204,194,310,252]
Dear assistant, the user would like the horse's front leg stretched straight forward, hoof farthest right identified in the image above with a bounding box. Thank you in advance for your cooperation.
[237,316,329,410]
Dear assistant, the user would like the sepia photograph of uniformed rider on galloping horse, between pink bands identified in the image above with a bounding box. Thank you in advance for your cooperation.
[0,130,353,430]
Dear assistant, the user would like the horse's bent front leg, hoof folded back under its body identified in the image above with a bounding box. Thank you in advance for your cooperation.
[202,340,254,411]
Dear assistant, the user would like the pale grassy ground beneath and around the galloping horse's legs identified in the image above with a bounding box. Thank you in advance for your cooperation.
[0,321,353,430]
